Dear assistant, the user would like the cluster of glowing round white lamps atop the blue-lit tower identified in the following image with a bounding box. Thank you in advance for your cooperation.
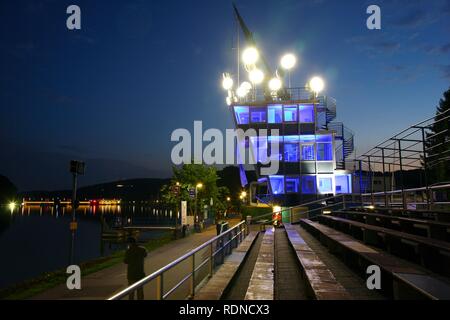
[222,47,324,105]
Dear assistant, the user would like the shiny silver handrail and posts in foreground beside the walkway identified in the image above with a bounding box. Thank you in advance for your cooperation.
[108,221,248,300]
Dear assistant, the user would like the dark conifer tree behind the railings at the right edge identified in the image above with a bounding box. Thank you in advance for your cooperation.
[425,88,450,183]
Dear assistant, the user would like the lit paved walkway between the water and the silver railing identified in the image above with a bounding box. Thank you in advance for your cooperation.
[32,219,240,300]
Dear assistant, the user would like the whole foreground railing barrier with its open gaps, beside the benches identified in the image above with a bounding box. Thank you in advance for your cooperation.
[108,221,249,300]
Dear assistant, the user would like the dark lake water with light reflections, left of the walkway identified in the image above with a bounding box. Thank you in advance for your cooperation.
[0,206,176,288]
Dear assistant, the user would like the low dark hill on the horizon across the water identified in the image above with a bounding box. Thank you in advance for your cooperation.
[19,178,170,200]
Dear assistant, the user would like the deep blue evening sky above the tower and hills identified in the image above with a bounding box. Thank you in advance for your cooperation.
[0,0,450,190]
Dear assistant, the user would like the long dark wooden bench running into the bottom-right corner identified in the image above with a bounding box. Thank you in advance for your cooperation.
[300,219,450,299]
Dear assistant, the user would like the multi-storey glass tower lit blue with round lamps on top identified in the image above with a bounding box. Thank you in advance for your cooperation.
[222,8,354,205]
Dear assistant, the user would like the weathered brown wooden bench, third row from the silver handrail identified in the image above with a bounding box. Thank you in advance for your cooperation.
[284,224,350,300]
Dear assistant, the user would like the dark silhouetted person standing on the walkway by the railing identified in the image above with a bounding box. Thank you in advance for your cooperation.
[123,238,147,300]
